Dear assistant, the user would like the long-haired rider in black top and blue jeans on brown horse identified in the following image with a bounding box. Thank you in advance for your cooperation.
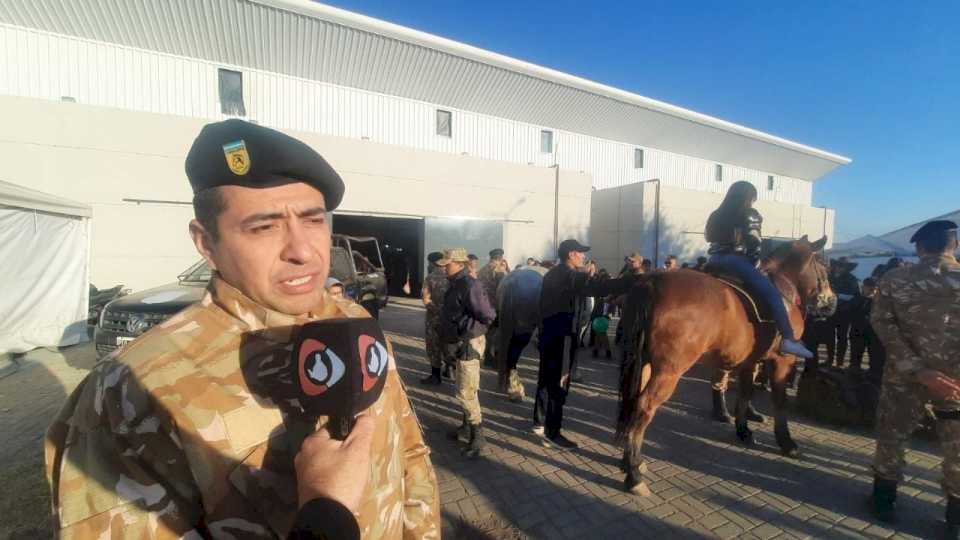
[706,180,813,358]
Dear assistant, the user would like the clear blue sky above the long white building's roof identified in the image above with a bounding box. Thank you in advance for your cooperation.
[328,0,960,240]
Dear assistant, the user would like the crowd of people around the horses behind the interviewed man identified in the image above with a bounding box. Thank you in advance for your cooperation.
[422,182,960,538]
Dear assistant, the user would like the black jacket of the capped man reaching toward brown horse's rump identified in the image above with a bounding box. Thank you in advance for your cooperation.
[540,264,639,339]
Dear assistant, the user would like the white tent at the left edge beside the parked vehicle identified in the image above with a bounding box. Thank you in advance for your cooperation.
[0,181,92,354]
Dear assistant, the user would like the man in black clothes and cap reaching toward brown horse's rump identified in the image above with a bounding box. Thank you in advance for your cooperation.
[533,239,637,448]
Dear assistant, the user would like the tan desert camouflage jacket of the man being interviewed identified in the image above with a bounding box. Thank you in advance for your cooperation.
[45,278,440,539]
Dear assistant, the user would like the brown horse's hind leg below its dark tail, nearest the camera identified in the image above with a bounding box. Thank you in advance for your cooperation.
[623,370,680,496]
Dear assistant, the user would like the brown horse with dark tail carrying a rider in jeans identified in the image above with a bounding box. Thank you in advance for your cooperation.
[617,236,837,495]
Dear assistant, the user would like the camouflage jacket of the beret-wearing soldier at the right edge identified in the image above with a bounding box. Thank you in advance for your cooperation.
[871,256,960,383]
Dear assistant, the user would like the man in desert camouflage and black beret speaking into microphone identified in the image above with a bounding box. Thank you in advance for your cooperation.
[45,120,440,539]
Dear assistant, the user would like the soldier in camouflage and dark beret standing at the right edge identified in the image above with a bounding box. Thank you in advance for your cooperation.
[871,221,960,537]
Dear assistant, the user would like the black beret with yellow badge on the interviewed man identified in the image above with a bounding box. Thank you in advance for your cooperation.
[185,119,344,210]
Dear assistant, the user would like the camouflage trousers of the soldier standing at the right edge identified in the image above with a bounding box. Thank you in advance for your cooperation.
[873,377,960,497]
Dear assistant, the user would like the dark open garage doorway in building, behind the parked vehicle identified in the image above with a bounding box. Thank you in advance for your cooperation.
[333,214,425,297]
